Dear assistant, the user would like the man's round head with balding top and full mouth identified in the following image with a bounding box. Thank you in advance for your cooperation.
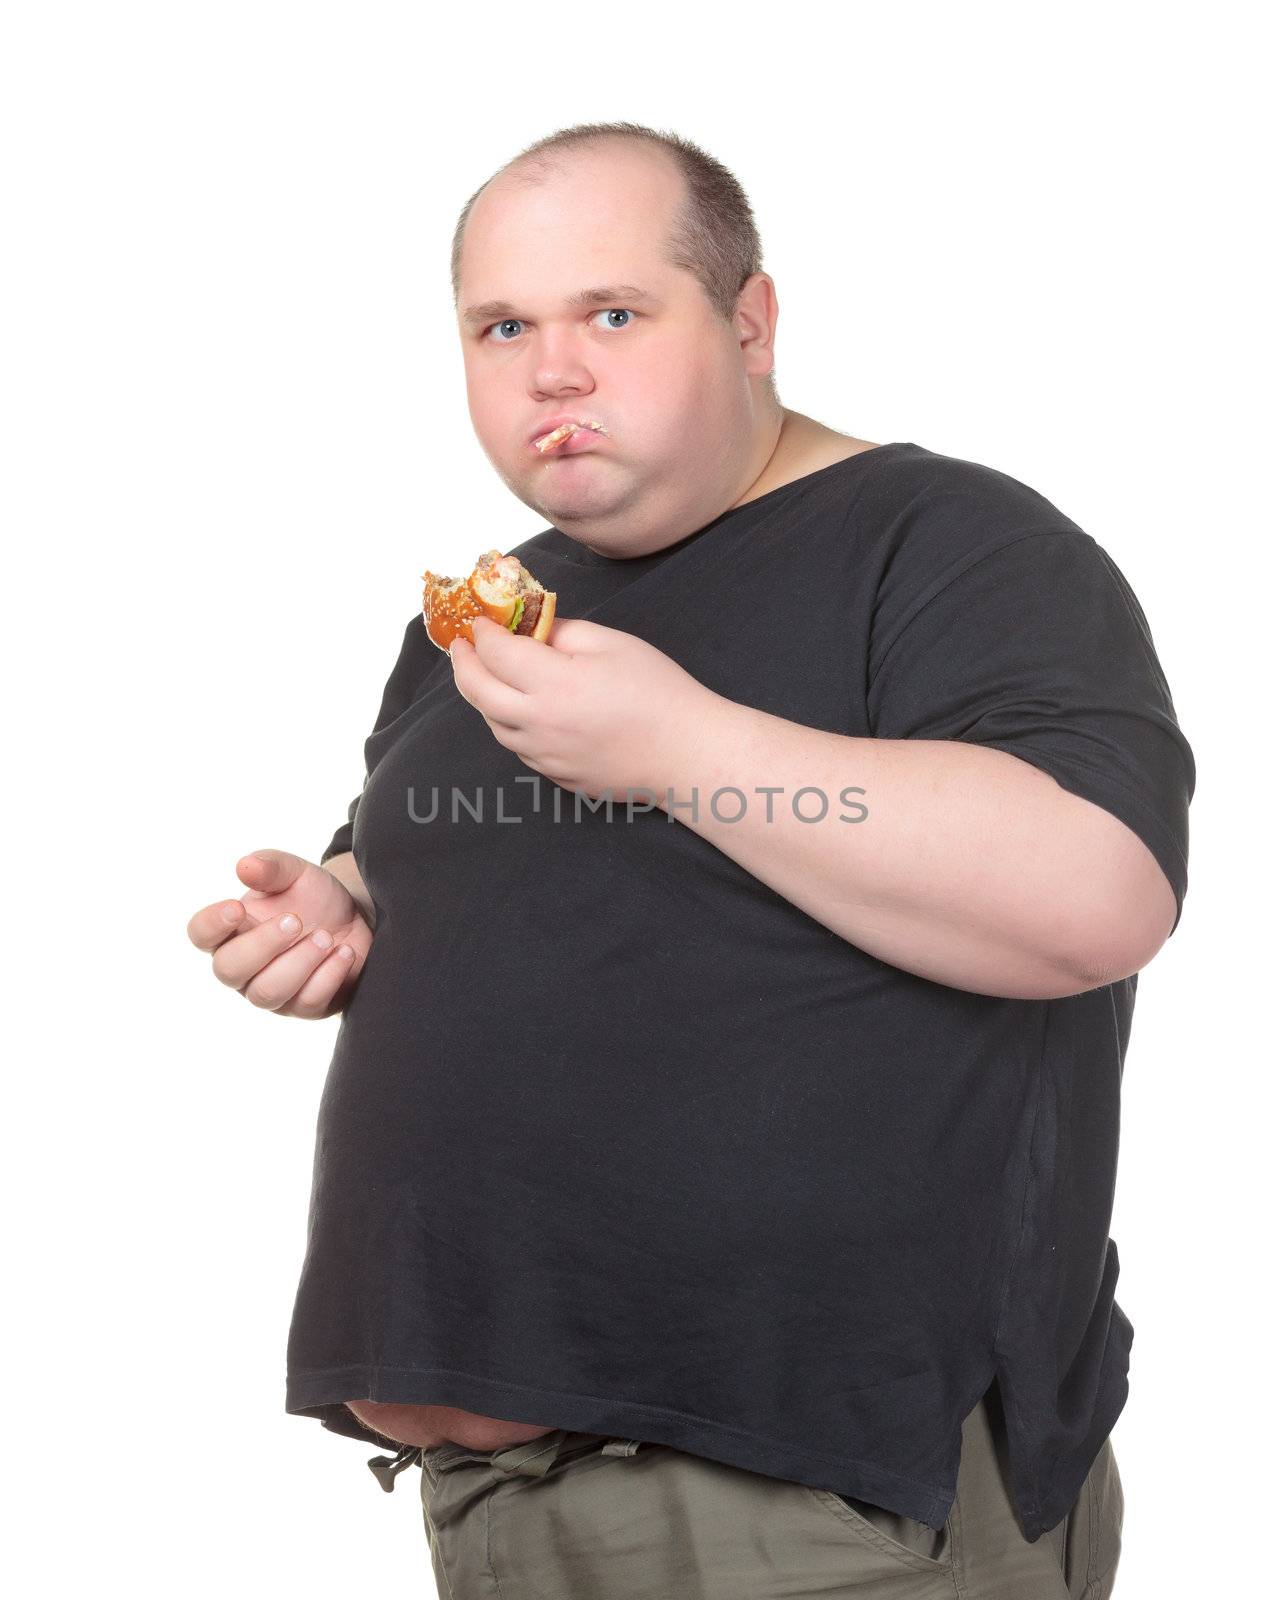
[451,123,783,557]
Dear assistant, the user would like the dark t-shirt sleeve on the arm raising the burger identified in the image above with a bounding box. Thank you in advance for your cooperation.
[869,530,1196,933]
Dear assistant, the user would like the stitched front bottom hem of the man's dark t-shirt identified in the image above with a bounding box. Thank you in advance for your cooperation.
[285,1365,954,1528]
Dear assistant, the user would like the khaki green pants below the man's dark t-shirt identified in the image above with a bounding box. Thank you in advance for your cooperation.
[363,1386,1122,1600]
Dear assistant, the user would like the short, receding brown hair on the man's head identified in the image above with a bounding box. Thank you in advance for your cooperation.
[450,122,778,398]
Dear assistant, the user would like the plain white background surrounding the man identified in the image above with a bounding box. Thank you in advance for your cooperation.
[0,0,1265,1600]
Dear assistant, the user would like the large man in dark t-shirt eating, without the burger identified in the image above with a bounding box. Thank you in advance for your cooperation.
[189,123,1194,1600]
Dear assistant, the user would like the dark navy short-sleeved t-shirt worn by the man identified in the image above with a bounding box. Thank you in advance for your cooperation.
[287,443,1194,1539]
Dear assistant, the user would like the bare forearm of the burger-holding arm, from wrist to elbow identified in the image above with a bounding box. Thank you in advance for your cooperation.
[660,694,1146,998]
